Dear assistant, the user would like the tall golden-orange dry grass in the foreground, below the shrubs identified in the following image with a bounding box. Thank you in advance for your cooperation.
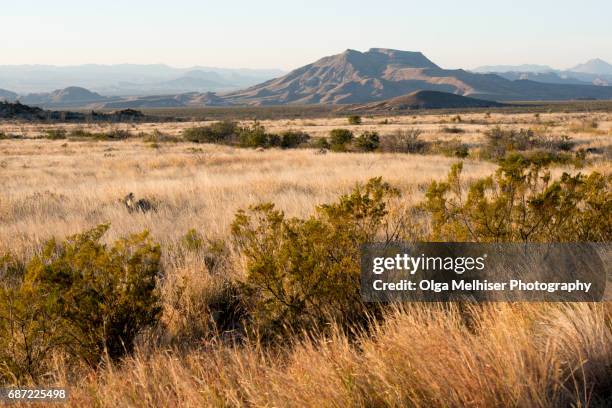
[51,304,612,408]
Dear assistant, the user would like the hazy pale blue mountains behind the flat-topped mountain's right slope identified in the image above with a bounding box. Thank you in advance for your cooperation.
[473,59,612,86]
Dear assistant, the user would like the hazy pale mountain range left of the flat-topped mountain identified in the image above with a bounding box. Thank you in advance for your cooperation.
[0,64,284,96]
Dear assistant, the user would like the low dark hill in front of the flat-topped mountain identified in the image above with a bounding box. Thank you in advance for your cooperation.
[350,91,508,112]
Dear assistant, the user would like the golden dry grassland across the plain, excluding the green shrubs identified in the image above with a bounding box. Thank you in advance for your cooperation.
[0,106,612,407]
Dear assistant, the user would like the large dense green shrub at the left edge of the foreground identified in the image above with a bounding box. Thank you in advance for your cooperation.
[0,225,161,379]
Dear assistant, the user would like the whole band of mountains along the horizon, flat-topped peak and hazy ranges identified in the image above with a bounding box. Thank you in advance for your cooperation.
[0,48,612,109]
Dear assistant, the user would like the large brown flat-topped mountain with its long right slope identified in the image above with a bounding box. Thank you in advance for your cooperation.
[224,48,612,105]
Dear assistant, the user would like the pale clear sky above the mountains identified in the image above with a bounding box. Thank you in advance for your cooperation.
[0,0,612,70]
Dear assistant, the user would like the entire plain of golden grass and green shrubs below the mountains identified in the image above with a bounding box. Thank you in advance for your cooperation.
[0,108,612,408]
